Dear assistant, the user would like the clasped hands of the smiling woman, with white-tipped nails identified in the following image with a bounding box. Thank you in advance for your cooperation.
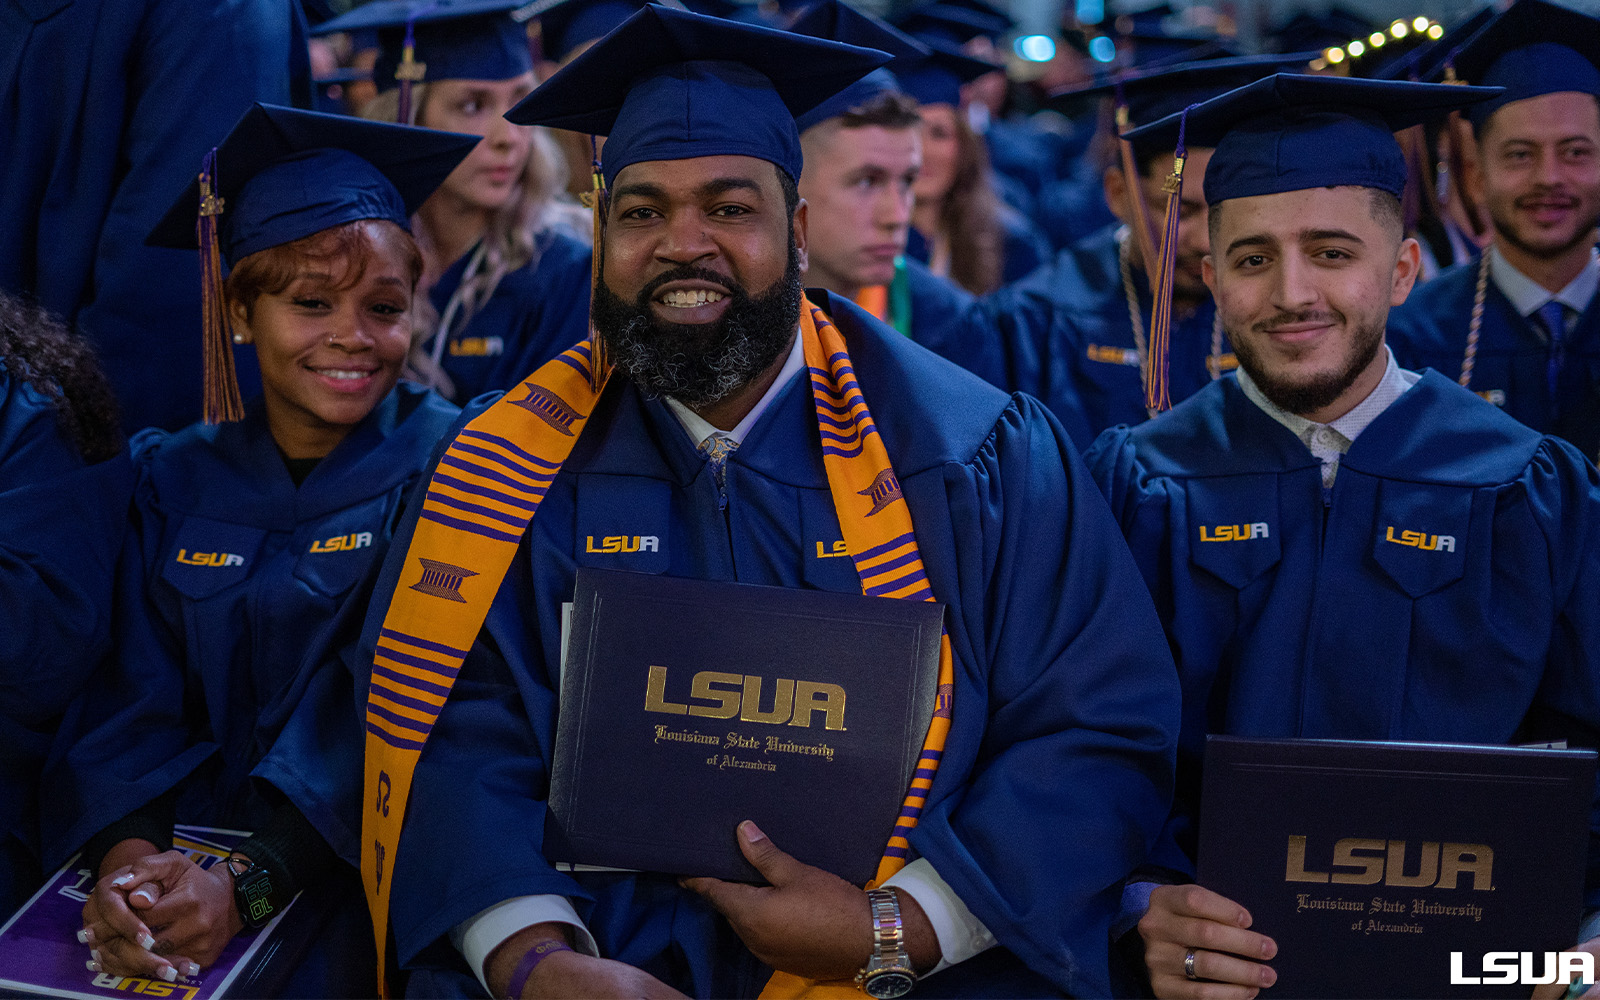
[78,842,243,982]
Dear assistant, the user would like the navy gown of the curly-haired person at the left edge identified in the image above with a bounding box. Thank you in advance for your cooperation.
[0,370,133,914]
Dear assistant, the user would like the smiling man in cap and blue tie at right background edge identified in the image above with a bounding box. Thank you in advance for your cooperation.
[1389,0,1600,461]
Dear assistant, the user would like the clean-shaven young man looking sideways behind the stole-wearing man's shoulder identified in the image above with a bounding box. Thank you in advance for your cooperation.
[789,0,1005,386]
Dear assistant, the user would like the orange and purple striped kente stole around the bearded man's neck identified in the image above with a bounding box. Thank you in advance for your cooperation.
[362,302,955,997]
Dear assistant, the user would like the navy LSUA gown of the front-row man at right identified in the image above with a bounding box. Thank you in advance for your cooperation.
[1086,371,1600,909]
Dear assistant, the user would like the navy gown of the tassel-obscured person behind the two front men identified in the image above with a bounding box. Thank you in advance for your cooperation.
[982,227,1232,450]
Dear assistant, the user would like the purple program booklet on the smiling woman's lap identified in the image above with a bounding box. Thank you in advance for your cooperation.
[0,826,293,1000]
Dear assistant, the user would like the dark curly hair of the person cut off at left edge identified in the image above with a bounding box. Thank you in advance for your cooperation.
[0,291,123,464]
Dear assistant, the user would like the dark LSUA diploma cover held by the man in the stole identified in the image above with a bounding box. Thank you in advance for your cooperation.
[544,568,944,885]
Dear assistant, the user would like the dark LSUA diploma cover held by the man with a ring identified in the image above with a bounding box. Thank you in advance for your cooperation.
[1198,736,1595,997]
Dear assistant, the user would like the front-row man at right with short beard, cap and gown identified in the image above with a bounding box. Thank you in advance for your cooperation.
[1088,75,1600,997]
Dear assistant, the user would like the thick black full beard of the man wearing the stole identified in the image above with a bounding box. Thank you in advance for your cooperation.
[594,236,805,408]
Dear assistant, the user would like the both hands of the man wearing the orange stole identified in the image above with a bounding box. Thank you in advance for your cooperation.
[491,821,939,997]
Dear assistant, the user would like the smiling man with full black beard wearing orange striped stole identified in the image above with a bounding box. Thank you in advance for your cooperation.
[362,6,1176,997]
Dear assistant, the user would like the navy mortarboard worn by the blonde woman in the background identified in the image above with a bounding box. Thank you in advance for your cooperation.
[312,0,533,91]
